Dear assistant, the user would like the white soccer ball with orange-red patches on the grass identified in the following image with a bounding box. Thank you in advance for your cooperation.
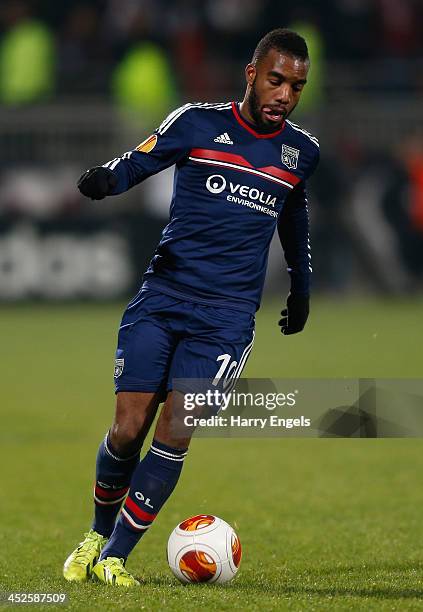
[167,514,241,584]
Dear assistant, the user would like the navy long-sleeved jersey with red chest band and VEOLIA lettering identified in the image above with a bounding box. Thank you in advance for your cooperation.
[104,102,319,313]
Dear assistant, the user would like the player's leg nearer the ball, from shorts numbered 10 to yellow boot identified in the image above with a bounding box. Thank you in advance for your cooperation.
[94,307,254,586]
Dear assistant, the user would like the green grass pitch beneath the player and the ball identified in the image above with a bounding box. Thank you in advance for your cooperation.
[0,298,423,611]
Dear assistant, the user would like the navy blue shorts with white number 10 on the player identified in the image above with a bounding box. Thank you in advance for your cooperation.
[114,289,255,397]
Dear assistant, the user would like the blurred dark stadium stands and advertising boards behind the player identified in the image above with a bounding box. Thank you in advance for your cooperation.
[0,0,423,302]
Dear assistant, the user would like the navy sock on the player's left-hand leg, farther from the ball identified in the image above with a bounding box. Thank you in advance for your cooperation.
[92,434,140,538]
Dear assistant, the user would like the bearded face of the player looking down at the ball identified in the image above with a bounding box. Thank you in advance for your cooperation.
[246,49,310,130]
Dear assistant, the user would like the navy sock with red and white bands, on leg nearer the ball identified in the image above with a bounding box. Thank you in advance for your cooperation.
[101,440,188,559]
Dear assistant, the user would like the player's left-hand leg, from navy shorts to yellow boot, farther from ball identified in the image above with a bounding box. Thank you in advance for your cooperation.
[63,294,175,581]
